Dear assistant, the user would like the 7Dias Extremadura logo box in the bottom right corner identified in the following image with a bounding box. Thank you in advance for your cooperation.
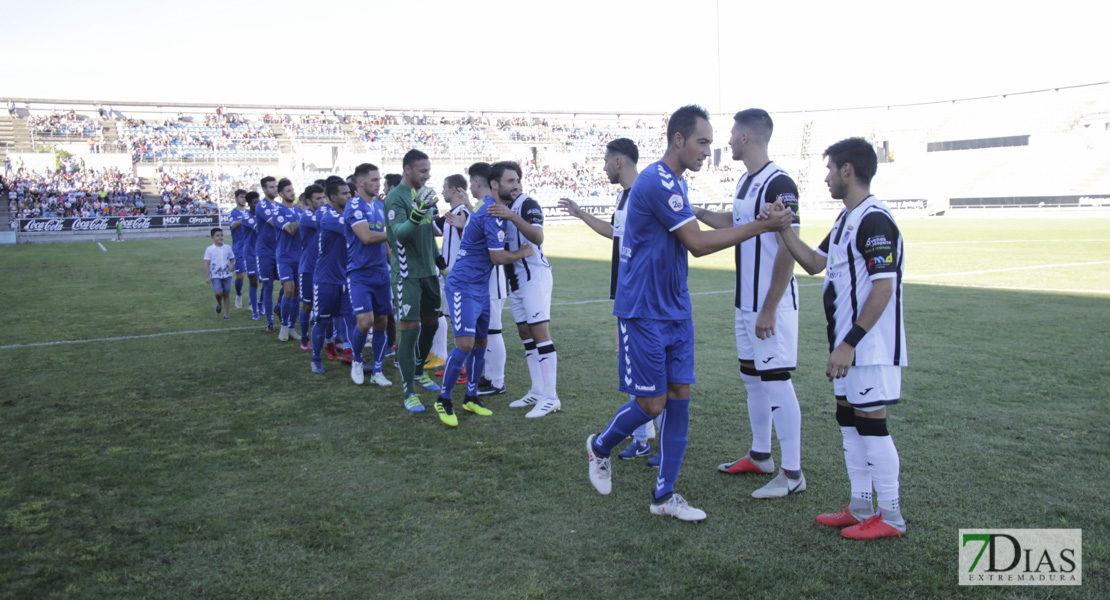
[959,529,1083,586]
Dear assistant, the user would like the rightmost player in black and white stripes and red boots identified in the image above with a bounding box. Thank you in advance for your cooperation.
[761,138,908,539]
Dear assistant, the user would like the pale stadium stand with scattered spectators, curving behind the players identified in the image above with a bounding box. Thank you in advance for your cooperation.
[0,83,1110,221]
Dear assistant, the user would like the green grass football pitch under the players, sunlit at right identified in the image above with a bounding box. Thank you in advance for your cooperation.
[0,218,1110,599]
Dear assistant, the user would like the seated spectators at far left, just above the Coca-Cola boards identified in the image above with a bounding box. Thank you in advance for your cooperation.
[8,169,144,218]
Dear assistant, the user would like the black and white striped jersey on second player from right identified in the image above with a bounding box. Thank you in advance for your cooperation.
[733,162,801,313]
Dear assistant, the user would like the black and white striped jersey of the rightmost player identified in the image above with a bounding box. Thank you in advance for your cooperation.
[817,196,908,366]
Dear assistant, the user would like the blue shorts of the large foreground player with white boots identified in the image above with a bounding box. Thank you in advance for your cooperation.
[617,318,697,398]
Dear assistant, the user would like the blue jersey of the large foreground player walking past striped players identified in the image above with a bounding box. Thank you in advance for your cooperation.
[613,161,694,321]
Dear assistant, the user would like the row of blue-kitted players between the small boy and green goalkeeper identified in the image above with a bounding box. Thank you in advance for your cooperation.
[229,173,393,386]
